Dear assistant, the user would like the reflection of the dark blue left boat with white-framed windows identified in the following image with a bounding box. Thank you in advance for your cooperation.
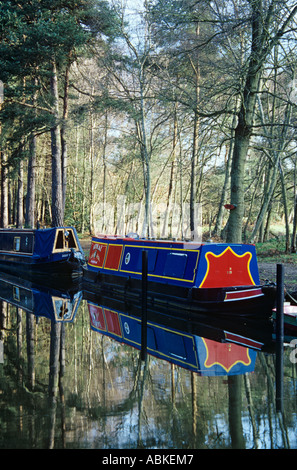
[0,273,82,322]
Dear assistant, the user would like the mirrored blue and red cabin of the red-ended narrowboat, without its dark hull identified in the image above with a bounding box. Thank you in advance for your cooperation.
[88,302,262,376]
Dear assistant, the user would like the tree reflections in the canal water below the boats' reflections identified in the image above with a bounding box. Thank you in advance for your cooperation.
[0,301,297,449]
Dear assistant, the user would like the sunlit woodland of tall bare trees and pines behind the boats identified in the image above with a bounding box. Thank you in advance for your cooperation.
[0,0,297,252]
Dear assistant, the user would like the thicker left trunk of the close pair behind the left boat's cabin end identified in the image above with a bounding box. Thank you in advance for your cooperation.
[51,60,64,227]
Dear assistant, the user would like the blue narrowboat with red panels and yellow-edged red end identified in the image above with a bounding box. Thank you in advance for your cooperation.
[84,236,275,316]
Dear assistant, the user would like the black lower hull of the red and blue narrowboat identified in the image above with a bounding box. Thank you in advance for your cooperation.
[83,269,275,316]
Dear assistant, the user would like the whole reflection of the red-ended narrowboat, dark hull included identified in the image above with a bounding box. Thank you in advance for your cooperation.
[87,296,271,376]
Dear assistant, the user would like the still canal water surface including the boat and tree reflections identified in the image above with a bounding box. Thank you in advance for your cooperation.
[0,276,297,452]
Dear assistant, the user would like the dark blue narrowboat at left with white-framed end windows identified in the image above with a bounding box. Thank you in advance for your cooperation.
[0,227,85,279]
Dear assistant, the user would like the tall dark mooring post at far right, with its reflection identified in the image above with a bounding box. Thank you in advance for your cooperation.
[275,264,284,412]
